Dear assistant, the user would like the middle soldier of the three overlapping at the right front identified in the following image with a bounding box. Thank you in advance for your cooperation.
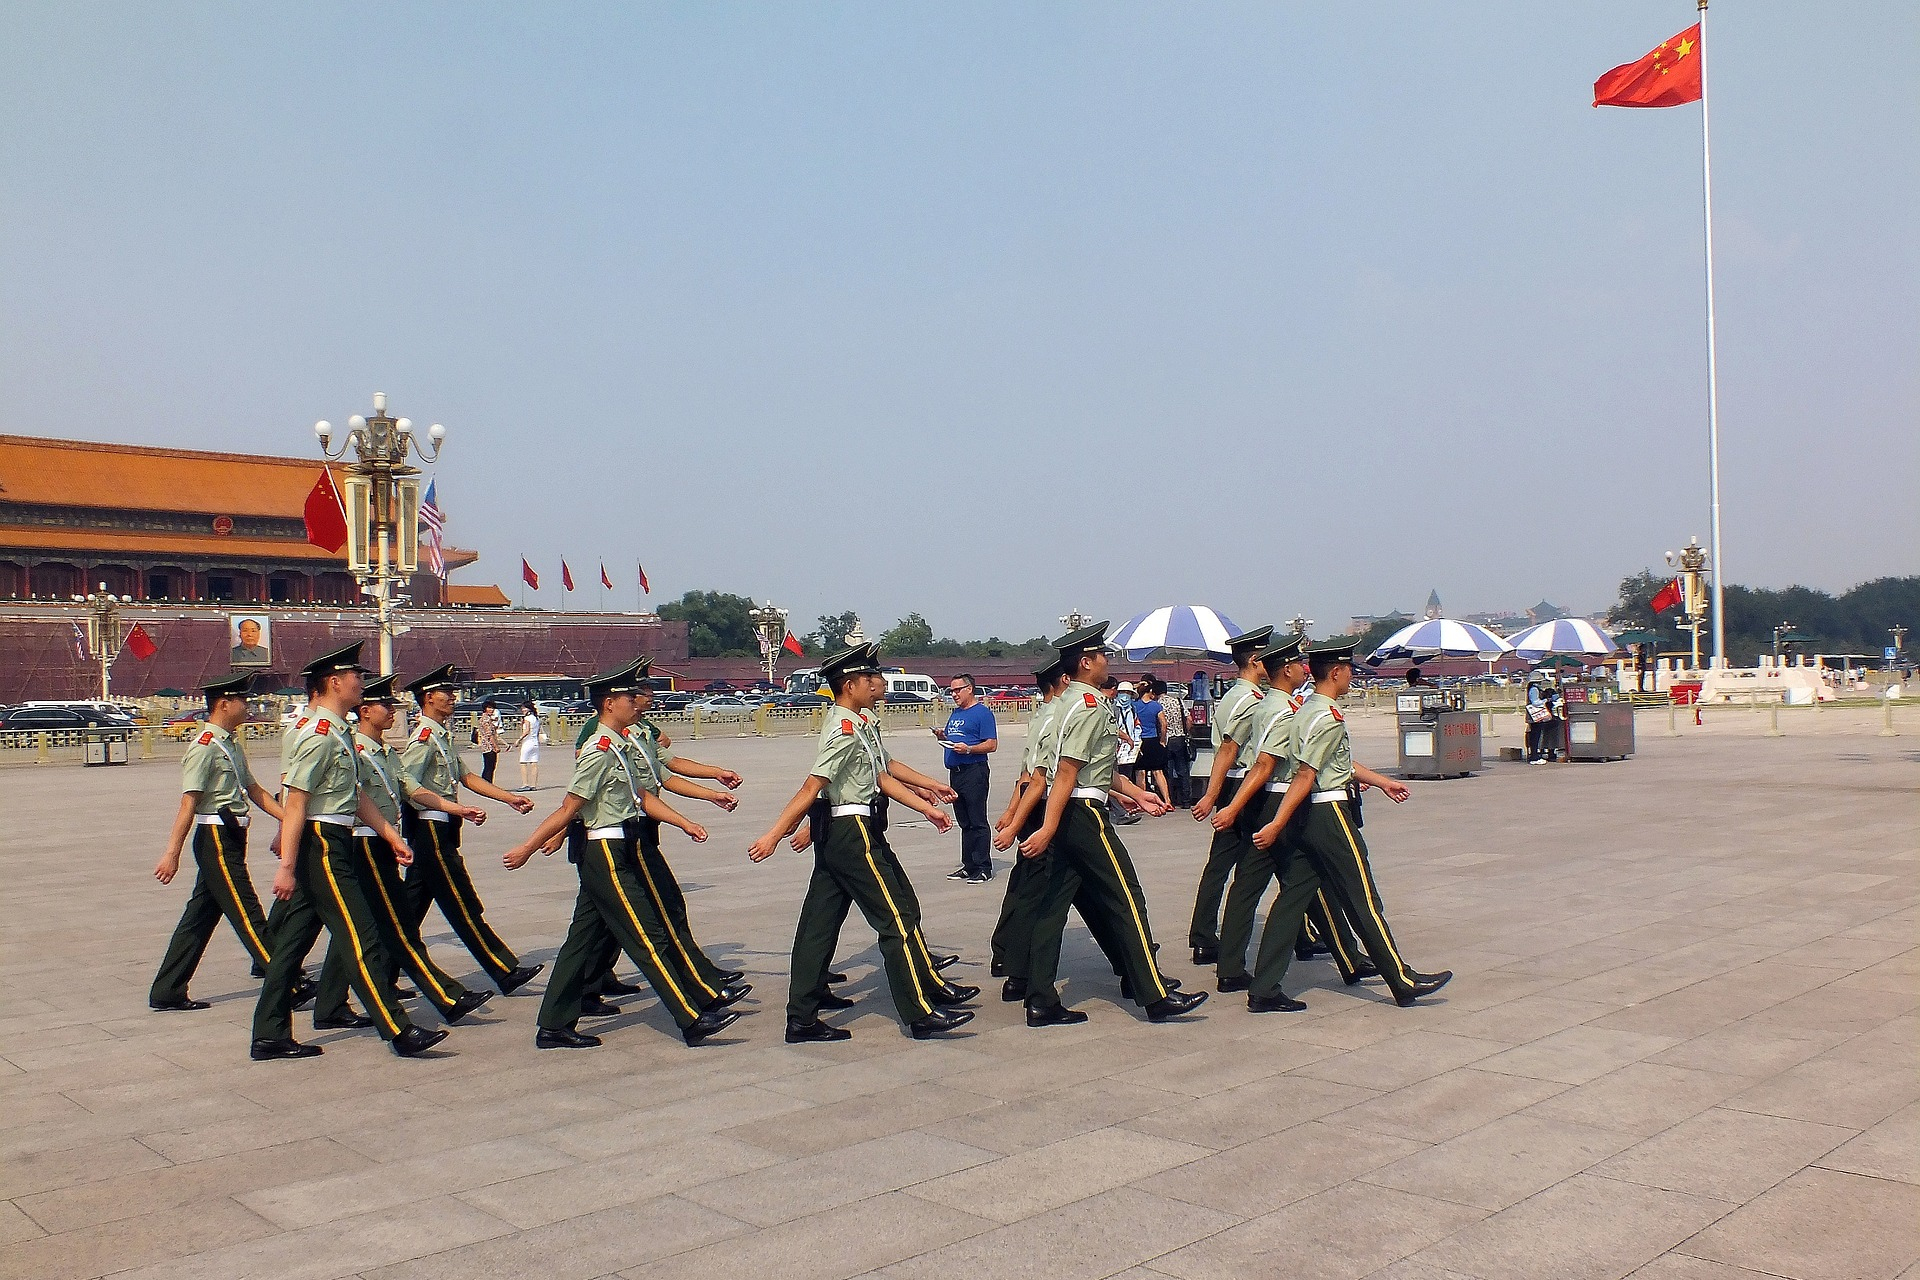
[1213,635,1379,992]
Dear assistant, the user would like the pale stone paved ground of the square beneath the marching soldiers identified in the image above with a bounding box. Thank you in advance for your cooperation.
[0,712,1920,1280]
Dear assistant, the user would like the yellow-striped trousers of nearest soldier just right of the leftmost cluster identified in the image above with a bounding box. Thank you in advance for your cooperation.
[540,839,710,1031]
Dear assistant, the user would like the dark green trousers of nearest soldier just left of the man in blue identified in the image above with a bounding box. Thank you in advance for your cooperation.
[787,816,939,1023]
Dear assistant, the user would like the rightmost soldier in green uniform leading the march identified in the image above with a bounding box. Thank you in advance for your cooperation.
[1246,639,1453,1013]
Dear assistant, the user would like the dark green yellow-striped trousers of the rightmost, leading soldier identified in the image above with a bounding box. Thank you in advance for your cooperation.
[1250,800,1413,996]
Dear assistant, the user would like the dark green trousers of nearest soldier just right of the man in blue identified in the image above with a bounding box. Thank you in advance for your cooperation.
[1025,796,1167,1009]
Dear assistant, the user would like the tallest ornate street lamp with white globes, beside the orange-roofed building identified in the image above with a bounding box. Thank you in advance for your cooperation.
[313,391,447,676]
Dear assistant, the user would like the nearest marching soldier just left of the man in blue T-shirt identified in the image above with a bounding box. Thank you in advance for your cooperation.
[747,645,979,1044]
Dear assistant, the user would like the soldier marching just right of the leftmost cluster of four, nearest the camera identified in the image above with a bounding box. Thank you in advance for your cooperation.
[503,662,747,1050]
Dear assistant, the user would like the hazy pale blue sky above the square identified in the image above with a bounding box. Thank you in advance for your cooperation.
[0,0,1920,637]
